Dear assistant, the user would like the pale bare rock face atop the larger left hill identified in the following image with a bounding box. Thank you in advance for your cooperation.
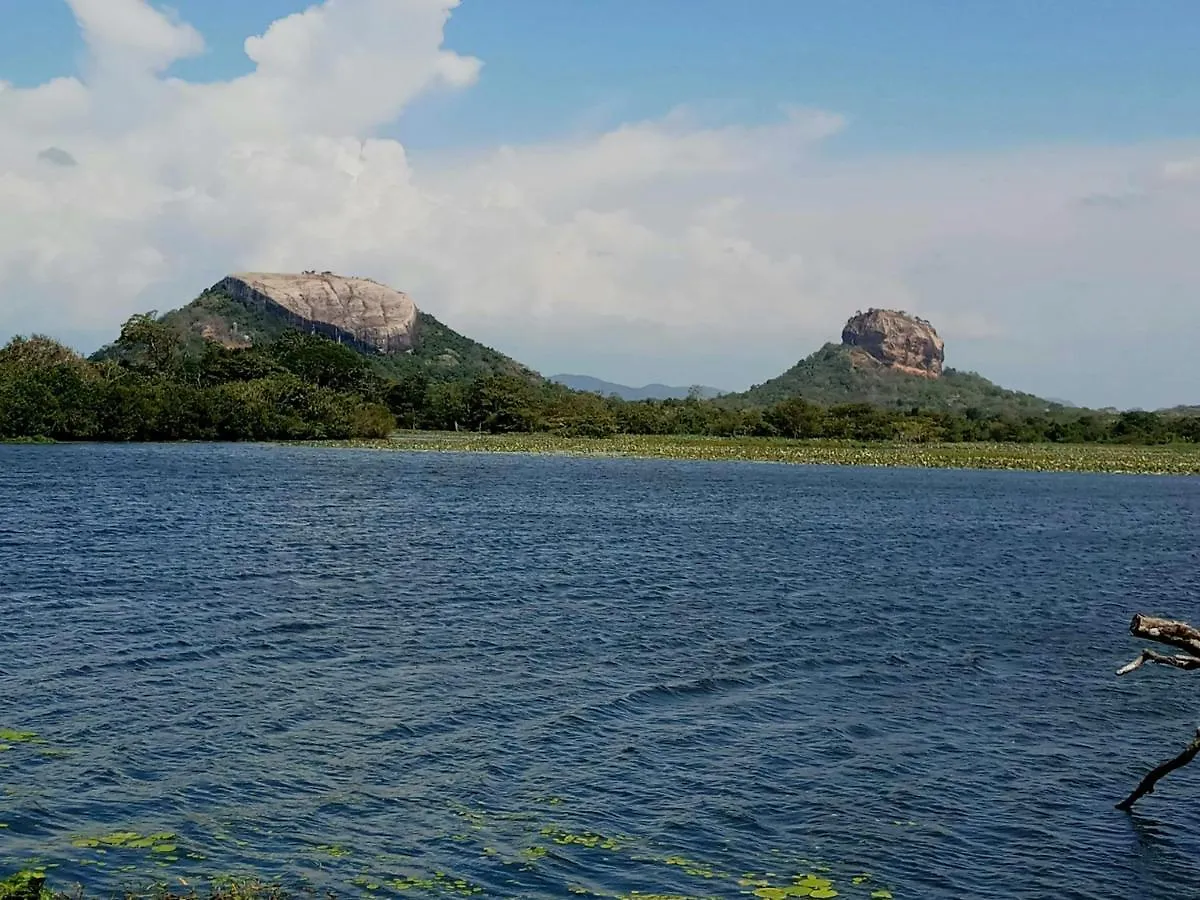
[216,272,416,353]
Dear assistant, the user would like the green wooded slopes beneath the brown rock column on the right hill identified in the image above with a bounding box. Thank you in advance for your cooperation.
[737,343,1062,416]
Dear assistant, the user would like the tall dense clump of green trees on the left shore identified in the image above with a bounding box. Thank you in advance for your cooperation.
[0,316,395,440]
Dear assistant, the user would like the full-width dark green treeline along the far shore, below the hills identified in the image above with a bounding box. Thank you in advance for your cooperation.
[0,316,1200,444]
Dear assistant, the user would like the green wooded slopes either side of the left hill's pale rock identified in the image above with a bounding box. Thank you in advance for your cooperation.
[142,289,540,382]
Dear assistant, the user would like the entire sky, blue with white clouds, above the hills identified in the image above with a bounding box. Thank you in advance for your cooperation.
[0,0,1200,408]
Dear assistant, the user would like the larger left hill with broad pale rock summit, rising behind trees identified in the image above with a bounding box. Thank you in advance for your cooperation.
[97,272,542,382]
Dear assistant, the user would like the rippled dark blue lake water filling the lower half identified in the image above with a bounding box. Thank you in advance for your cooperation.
[0,446,1200,899]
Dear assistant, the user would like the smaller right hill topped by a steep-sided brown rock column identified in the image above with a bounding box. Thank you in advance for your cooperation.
[731,310,1063,415]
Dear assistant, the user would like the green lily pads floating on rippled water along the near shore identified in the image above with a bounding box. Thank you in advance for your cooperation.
[0,728,916,900]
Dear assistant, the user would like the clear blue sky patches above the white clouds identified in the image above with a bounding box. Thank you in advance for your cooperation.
[9,0,1200,152]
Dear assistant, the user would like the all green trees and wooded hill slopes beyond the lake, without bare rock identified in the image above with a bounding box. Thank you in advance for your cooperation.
[0,290,1200,458]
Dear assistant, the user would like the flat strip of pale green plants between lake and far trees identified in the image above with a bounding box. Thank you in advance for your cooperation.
[313,432,1200,475]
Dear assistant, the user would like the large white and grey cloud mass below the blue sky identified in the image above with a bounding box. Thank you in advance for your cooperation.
[0,0,1200,404]
